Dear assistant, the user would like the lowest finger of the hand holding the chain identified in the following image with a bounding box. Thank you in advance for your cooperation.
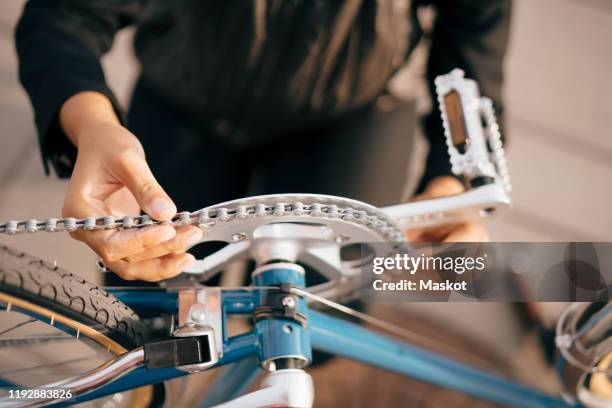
[106,250,195,282]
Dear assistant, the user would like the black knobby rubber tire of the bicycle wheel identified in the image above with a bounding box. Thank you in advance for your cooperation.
[0,246,149,350]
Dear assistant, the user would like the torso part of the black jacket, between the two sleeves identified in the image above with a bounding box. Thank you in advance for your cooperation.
[135,0,418,131]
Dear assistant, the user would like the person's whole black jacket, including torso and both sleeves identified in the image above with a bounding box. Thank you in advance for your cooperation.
[16,0,510,188]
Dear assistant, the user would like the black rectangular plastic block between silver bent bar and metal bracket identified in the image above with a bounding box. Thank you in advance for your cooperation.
[144,336,212,368]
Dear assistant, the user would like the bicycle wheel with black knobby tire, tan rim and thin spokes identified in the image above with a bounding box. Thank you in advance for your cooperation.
[0,246,153,407]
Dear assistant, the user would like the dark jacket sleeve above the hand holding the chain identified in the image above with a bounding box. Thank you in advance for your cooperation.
[15,0,140,177]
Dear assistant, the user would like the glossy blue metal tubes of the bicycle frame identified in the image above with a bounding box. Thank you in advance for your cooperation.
[63,262,568,407]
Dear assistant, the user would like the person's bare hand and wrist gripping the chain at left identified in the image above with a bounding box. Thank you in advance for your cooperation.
[60,92,202,281]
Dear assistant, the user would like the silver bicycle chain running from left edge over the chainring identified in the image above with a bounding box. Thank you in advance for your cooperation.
[0,202,404,242]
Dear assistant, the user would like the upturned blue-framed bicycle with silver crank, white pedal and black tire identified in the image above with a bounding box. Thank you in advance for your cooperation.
[0,70,605,408]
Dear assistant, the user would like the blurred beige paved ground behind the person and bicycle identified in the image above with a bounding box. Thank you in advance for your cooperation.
[0,0,612,404]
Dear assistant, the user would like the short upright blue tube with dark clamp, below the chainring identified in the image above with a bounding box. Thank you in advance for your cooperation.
[252,262,312,371]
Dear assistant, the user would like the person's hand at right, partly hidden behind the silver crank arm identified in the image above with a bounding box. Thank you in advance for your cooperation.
[404,176,489,242]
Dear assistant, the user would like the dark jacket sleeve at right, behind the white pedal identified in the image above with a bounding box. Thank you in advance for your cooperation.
[418,0,511,192]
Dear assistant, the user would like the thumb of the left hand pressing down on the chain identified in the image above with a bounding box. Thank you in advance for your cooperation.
[117,151,176,221]
